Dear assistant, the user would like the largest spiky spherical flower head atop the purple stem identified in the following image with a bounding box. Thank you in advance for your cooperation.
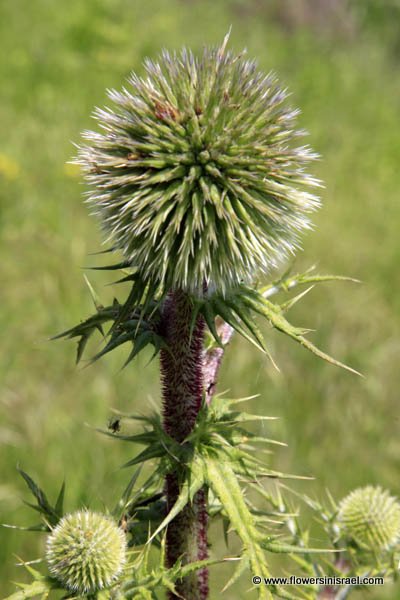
[77,38,319,293]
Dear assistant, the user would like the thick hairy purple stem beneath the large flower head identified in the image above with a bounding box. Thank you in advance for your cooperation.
[160,290,208,600]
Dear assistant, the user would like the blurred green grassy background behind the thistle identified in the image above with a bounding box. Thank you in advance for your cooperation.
[0,0,400,599]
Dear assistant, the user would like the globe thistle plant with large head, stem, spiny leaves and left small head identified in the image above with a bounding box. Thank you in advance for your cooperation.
[5,36,382,600]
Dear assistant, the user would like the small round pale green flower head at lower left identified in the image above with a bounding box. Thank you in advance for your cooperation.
[46,511,126,594]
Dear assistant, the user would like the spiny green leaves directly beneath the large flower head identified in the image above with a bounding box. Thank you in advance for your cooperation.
[53,263,360,375]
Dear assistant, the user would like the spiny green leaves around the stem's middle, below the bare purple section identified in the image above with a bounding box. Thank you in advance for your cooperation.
[98,396,326,598]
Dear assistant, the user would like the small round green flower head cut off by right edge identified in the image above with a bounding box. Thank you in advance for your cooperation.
[337,486,400,553]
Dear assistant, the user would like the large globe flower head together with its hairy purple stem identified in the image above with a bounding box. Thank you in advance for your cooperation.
[78,34,324,598]
